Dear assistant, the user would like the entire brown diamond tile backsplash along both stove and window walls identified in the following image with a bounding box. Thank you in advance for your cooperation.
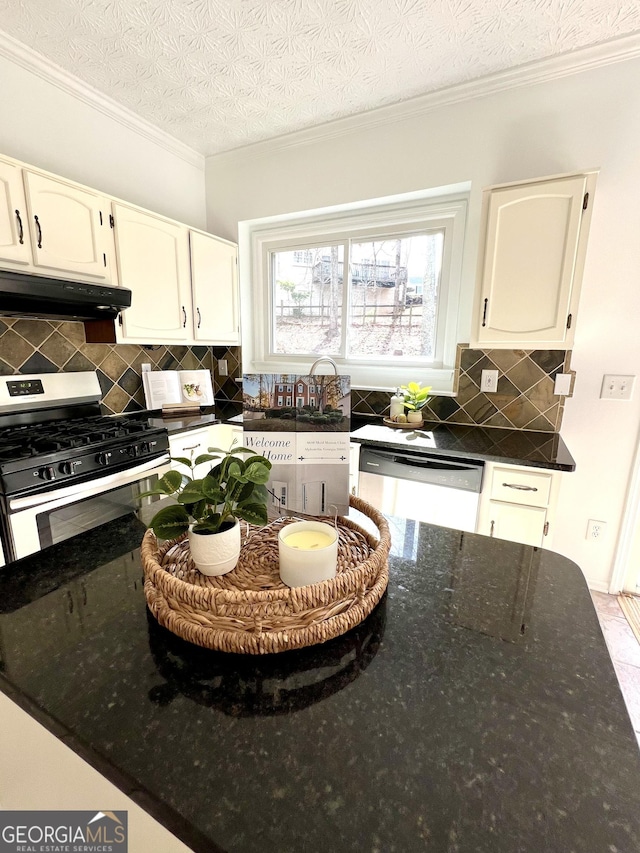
[0,318,571,432]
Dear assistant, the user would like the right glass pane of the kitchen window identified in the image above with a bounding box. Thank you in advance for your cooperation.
[347,231,444,359]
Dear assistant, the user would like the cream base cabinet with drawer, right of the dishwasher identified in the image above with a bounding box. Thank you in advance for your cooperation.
[476,462,561,548]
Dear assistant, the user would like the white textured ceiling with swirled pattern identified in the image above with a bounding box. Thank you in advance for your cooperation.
[0,0,640,154]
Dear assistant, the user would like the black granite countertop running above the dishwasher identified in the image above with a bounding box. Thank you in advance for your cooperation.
[351,421,576,471]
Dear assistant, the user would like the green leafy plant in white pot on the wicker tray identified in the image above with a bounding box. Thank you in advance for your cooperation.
[141,441,271,575]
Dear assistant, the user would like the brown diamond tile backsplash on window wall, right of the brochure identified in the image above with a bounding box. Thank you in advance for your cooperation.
[351,344,571,432]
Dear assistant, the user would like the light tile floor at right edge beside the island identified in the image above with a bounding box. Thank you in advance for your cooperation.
[591,592,640,745]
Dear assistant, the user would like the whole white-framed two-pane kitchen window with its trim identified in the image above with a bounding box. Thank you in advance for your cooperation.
[241,188,467,395]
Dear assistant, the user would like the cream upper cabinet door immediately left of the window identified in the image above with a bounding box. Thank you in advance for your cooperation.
[190,231,240,344]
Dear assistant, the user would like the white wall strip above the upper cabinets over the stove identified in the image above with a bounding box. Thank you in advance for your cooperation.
[0,56,205,228]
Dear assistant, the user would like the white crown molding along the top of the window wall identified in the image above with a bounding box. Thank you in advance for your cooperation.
[207,34,640,160]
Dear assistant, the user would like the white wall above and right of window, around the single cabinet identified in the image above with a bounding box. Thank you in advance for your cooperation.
[206,60,640,589]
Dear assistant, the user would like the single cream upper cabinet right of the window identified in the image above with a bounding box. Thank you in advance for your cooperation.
[471,172,596,349]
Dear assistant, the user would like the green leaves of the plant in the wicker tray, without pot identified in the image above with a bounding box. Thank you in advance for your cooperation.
[140,442,271,539]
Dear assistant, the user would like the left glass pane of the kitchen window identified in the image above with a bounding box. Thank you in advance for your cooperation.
[271,246,344,355]
